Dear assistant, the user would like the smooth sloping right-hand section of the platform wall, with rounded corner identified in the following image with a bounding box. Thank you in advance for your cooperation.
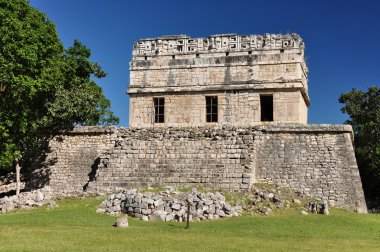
[255,125,366,212]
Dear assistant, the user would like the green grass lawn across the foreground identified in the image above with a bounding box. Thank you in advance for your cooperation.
[0,198,380,251]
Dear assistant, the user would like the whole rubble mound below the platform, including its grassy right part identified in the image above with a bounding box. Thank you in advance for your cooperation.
[96,186,320,222]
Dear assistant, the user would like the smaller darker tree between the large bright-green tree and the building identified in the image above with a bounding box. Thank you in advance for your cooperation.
[43,40,119,129]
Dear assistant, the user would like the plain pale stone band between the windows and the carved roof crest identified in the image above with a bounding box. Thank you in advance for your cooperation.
[130,55,306,92]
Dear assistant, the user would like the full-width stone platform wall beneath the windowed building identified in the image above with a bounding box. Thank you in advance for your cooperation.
[37,124,366,212]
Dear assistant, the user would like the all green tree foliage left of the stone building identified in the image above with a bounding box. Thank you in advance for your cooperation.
[0,0,118,171]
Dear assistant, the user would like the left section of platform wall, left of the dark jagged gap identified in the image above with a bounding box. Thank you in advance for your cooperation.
[44,127,117,193]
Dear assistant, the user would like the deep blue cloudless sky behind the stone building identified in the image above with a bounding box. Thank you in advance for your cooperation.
[30,0,380,126]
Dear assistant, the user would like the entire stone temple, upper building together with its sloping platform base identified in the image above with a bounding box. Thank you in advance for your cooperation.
[31,34,367,212]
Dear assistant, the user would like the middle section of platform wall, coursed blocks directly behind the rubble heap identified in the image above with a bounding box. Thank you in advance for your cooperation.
[90,128,253,192]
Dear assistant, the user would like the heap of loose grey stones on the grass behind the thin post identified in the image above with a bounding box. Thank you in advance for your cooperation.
[97,187,243,222]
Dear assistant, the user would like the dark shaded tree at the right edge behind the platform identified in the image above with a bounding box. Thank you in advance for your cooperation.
[339,86,380,204]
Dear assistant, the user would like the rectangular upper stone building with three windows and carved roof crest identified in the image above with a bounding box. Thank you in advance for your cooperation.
[128,34,310,127]
